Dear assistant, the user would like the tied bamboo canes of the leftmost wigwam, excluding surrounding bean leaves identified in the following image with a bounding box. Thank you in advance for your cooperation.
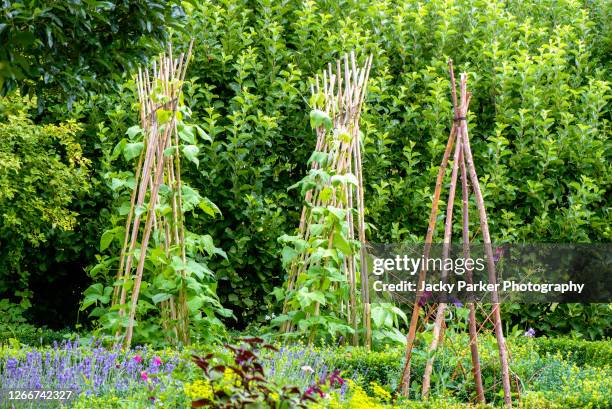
[112,42,193,346]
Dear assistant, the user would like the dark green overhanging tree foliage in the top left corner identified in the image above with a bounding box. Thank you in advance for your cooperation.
[0,0,184,102]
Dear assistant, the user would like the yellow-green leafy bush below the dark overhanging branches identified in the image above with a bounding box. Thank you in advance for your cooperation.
[0,95,89,308]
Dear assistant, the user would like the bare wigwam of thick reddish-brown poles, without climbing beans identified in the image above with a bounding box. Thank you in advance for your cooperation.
[400,61,512,408]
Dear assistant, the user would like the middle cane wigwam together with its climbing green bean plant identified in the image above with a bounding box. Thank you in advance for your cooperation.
[281,52,373,346]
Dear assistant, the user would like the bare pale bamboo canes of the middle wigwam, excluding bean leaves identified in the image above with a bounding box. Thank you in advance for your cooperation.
[281,52,373,347]
